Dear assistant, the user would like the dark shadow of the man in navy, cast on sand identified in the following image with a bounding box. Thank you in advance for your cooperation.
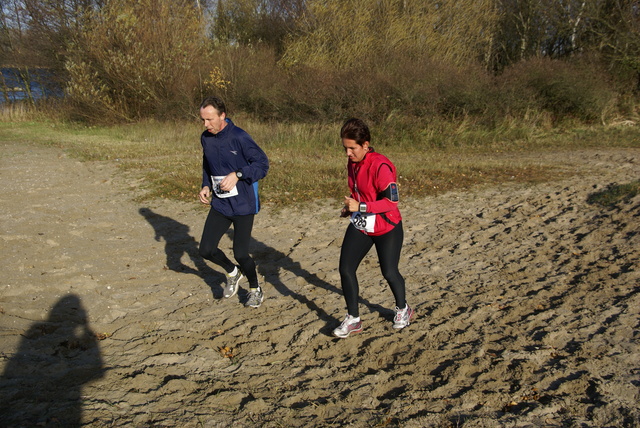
[138,208,225,299]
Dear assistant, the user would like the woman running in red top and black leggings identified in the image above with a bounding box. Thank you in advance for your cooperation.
[333,119,413,337]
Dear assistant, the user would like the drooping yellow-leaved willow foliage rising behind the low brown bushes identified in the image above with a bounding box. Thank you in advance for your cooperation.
[284,0,497,68]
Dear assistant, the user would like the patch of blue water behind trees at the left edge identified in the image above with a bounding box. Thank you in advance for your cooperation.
[0,68,64,103]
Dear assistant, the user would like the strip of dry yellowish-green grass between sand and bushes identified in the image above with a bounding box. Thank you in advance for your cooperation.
[0,116,640,205]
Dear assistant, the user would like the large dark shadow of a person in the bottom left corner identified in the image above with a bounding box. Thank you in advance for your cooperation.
[0,294,104,428]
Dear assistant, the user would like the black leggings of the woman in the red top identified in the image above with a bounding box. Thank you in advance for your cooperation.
[340,222,406,317]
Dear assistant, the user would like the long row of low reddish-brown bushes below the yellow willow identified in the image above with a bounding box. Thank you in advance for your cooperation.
[211,48,617,126]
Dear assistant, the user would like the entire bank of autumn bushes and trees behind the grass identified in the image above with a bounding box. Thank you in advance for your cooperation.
[0,0,640,128]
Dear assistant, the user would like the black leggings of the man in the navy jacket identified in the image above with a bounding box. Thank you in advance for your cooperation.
[200,208,259,288]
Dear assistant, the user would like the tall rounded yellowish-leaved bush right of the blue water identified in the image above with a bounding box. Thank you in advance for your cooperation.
[66,0,207,122]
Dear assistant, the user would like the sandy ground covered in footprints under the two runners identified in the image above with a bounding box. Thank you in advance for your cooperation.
[0,140,640,427]
